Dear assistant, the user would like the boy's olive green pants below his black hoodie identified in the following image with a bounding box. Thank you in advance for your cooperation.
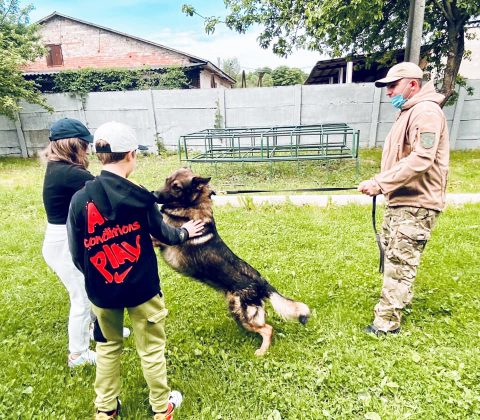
[92,295,170,413]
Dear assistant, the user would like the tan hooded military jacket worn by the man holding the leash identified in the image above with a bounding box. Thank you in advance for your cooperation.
[374,82,449,210]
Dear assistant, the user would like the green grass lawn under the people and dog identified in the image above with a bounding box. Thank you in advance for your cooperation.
[0,150,480,420]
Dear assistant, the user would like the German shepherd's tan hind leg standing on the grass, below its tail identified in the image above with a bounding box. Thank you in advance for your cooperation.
[227,293,273,356]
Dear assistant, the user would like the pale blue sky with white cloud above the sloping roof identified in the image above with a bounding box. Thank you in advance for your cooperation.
[28,0,324,73]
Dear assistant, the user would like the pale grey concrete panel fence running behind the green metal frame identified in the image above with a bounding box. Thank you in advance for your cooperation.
[0,80,480,157]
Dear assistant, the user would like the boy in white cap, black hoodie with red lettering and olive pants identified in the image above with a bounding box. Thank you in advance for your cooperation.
[67,122,203,420]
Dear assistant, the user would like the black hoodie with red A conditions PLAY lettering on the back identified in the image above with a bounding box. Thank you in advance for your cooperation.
[67,171,188,308]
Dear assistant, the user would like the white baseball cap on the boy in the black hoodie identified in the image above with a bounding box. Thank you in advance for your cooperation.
[93,121,148,153]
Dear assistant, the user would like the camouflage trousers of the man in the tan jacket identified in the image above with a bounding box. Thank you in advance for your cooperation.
[373,206,439,331]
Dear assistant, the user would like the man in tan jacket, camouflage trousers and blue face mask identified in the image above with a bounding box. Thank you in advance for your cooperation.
[358,62,449,336]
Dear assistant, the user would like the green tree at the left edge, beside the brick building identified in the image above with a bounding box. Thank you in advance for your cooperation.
[0,0,51,118]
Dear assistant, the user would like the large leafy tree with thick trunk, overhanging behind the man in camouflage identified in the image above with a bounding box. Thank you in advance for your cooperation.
[182,0,480,103]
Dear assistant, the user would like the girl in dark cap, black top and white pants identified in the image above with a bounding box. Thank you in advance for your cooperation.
[42,118,130,368]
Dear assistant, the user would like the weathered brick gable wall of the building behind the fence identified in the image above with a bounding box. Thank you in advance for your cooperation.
[24,16,189,72]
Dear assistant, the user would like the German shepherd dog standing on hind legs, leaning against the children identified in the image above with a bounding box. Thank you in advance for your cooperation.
[155,168,310,356]
